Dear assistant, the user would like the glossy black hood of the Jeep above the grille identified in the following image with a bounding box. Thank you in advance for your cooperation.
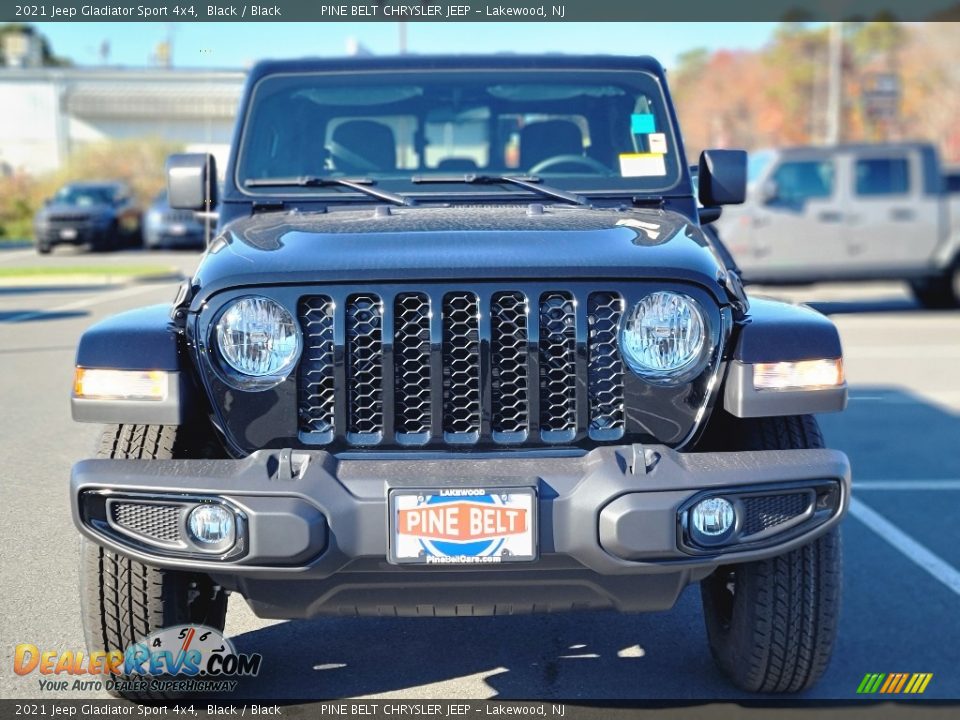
[188,205,726,303]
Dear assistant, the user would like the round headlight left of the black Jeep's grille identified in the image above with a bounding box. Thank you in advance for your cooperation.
[216,297,300,389]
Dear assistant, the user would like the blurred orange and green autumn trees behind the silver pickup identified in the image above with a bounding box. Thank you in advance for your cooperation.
[671,21,960,163]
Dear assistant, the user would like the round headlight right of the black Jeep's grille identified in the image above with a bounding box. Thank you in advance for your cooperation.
[620,291,707,384]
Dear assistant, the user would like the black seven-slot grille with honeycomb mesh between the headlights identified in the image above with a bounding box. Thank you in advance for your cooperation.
[298,288,625,447]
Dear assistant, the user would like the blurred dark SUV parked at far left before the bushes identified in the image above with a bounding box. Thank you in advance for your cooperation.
[33,182,140,255]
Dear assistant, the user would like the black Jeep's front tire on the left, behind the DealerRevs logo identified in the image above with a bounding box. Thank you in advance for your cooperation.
[80,425,227,699]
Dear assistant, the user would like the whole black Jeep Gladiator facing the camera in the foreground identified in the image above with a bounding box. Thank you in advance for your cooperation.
[71,56,850,692]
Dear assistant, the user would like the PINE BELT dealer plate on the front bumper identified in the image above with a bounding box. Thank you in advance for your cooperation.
[389,488,537,565]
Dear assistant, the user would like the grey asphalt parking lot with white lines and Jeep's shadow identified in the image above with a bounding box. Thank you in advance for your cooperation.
[0,245,960,700]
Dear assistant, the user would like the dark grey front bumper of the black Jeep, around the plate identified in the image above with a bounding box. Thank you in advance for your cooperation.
[71,445,850,617]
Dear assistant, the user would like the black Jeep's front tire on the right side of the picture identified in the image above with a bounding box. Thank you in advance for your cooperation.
[700,416,842,692]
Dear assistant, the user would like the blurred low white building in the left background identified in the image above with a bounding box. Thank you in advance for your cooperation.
[0,68,245,173]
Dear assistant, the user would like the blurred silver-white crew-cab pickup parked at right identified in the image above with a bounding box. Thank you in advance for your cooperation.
[717,143,960,307]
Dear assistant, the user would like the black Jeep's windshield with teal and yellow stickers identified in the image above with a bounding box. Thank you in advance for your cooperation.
[236,69,690,195]
